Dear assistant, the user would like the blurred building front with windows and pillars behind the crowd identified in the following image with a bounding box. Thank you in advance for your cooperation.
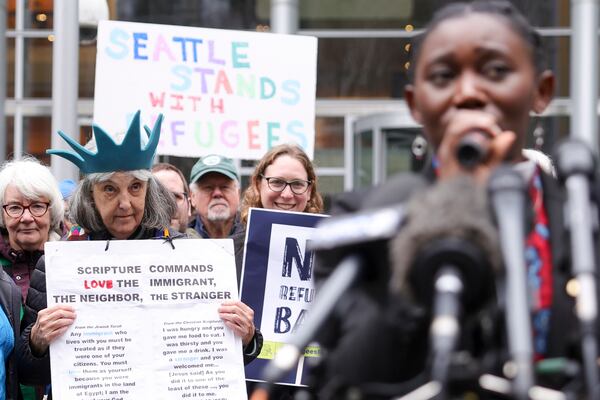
[0,0,571,209]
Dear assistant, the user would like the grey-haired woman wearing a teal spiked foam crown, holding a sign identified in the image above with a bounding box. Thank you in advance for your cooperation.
[22,111,262,392]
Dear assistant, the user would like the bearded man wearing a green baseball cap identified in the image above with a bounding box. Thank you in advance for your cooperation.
[190,154,242,239]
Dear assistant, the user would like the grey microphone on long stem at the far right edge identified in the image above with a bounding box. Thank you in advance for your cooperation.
[557,140,600,399]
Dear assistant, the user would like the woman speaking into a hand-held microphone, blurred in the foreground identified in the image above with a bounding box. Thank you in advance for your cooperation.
[315,0,578,399]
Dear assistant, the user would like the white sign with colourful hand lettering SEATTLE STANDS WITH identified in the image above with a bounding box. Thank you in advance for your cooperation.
[94,21,317,159]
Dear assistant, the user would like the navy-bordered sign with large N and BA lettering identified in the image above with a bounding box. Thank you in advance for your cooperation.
[241,208,326,385]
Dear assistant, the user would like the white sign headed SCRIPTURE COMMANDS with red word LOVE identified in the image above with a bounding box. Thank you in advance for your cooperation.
[45,239,246,400]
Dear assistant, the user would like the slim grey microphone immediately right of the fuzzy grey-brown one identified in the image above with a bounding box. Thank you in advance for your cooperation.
[488,166,534,400]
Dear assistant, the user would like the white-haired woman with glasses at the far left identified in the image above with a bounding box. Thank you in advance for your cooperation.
[0,157,64,300]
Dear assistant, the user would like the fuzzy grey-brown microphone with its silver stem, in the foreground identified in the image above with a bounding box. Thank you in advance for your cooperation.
[391,176,500,394]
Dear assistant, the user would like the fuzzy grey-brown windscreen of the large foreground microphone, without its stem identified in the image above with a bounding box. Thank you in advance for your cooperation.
[390,176,501,306]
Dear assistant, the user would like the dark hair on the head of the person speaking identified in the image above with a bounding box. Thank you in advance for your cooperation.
[409,0,547,82]
